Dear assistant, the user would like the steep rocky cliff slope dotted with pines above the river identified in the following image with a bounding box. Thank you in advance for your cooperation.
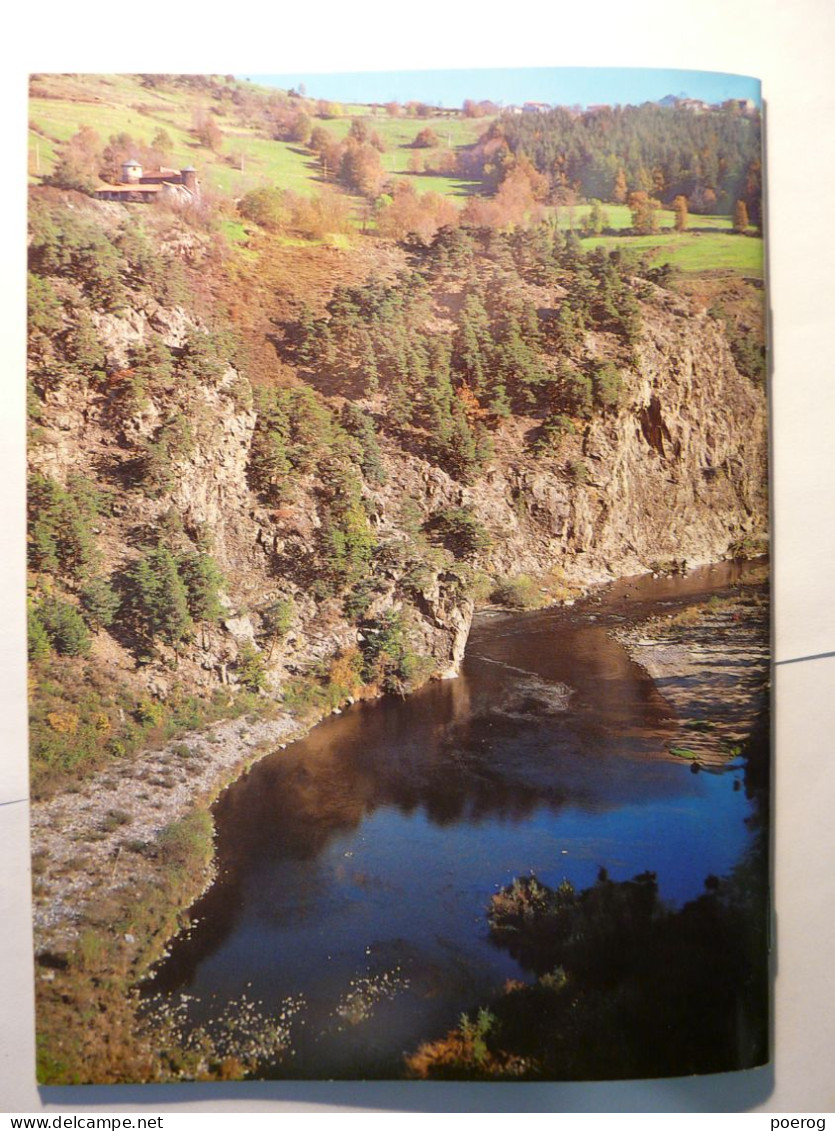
[24,186,767,750]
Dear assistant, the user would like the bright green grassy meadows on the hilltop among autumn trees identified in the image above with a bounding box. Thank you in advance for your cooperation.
[28,75,764,276]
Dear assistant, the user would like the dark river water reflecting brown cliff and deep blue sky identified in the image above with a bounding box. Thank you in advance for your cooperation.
[152,566,751,1077]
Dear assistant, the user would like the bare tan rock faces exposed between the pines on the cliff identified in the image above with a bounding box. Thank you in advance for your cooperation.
[32,272,767,701]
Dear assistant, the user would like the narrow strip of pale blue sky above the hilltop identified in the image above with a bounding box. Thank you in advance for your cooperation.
[239,67,760,106]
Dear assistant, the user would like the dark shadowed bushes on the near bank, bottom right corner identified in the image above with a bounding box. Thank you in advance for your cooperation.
[406,845,768,1080]
